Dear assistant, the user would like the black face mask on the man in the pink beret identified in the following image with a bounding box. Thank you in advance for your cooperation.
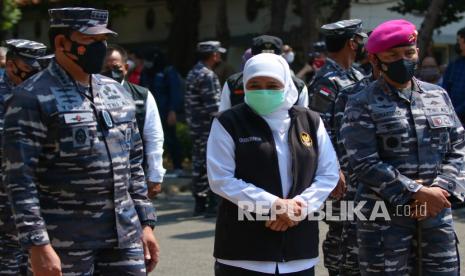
[376,57,418,84]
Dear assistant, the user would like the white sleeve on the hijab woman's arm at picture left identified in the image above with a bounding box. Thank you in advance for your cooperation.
[207,119,278,215]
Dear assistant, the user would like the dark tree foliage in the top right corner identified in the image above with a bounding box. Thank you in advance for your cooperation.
[389,0,465,28]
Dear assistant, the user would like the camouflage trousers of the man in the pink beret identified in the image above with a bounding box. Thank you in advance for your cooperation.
[357,209,459,276]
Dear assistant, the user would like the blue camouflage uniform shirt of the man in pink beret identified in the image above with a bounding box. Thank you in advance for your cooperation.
[341,78,465,214]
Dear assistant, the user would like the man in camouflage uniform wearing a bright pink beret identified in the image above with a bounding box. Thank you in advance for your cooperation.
[341,20,465,276]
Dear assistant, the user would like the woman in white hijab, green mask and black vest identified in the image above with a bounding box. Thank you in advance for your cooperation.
[207,53,339,276]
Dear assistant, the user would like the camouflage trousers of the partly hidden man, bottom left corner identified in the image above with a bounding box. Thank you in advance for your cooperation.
[0,232,27,276]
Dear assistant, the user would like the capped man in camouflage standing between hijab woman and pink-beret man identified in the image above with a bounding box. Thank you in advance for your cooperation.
[310,19,366,275]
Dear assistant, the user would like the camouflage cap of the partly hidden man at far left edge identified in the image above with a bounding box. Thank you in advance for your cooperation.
[5,39,47,68]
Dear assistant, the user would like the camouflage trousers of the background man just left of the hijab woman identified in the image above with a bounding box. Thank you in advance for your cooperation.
[191,130,210,197]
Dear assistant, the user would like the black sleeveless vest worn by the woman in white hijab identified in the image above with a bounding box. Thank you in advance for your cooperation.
[214,104,320,262]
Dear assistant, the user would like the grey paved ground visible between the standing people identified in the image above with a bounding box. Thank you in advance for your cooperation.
[150,194,465,276]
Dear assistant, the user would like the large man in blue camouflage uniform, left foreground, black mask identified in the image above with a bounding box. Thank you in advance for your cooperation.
[3,8,158,276]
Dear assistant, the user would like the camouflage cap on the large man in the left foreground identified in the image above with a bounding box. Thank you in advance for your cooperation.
[48,8,117,35]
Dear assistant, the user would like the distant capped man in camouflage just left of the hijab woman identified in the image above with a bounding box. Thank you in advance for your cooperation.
[185,41,222,216]
